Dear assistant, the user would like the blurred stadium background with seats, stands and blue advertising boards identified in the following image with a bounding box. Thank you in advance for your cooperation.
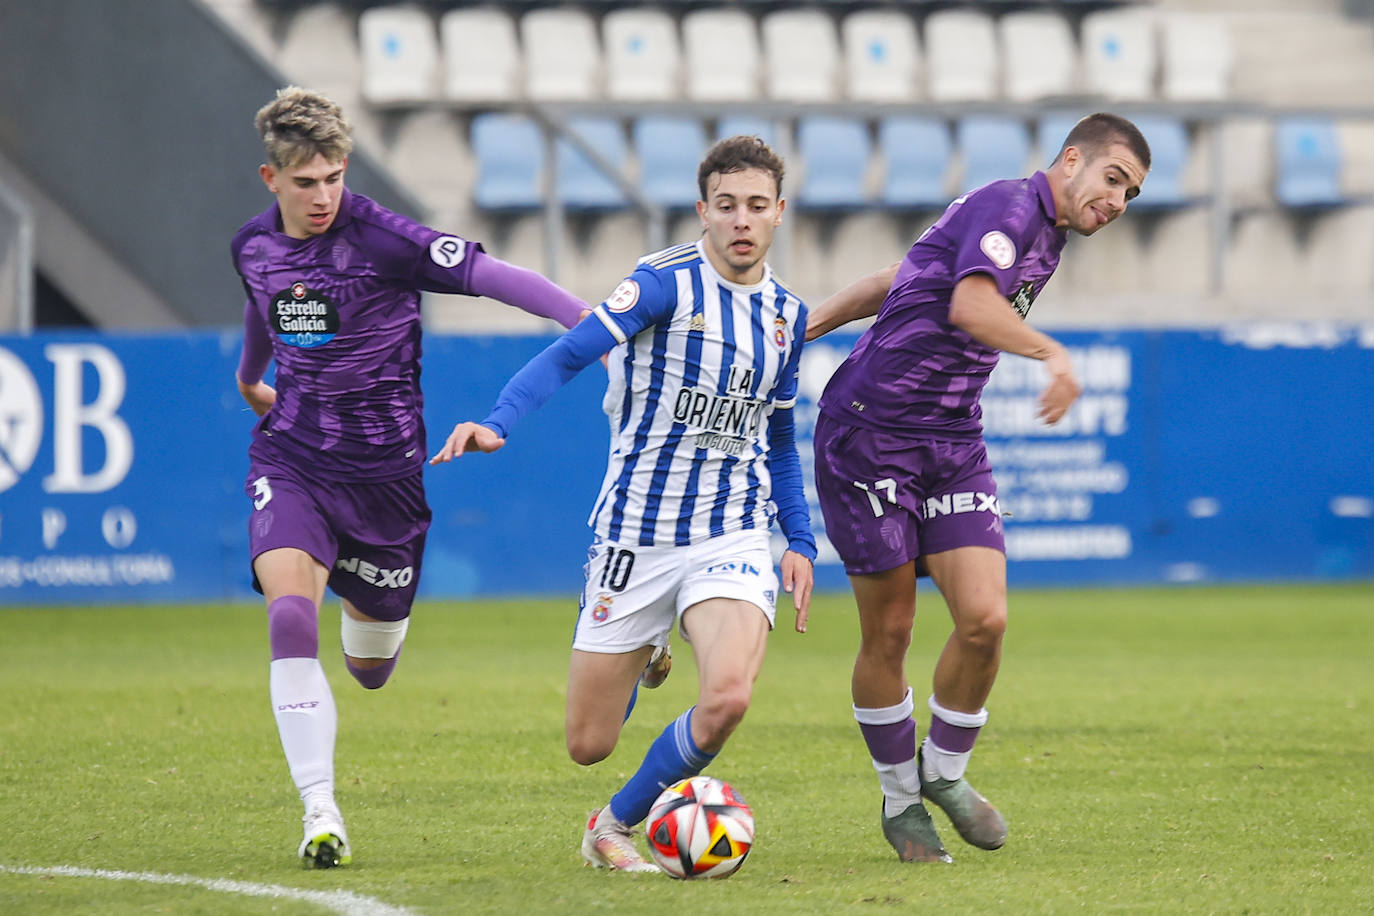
[0,0,1374,603]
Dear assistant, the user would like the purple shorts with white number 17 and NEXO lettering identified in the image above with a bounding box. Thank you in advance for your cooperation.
[815,413,1006,575]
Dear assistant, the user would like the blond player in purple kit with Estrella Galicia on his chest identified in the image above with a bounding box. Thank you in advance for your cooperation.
[232,87,587,868]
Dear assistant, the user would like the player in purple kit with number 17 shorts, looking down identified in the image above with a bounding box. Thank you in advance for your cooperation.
[807,114,1150,862]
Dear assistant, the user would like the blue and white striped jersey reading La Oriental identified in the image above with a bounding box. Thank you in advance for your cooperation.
[588,242,807,547]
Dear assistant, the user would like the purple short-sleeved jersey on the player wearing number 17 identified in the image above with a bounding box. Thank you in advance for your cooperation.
[820,172,1068,439]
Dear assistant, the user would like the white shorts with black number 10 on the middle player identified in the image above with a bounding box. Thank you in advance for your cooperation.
[573,530,778,654]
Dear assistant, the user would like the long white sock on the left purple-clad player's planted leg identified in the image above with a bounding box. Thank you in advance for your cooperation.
[269,658,338,799]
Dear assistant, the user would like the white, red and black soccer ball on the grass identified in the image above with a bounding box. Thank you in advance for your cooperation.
[647,776,754,878]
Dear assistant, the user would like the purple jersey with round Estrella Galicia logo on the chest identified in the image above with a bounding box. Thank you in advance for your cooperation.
[232,190,485,481]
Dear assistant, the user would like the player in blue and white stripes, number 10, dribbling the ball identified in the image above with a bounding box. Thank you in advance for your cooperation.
[431,137,816,871]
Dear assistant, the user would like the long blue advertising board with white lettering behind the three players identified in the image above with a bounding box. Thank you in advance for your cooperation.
[0,324,1374,606]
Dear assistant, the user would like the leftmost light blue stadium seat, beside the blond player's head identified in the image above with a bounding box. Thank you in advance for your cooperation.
[471,113,545,210]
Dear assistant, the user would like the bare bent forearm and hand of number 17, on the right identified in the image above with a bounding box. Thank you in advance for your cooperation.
[949,273,1083,426]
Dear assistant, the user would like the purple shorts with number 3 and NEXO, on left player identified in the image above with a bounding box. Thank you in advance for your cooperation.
[243,460,431,621]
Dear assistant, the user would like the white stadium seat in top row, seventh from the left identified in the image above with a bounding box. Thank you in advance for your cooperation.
[840,10,921,103]
